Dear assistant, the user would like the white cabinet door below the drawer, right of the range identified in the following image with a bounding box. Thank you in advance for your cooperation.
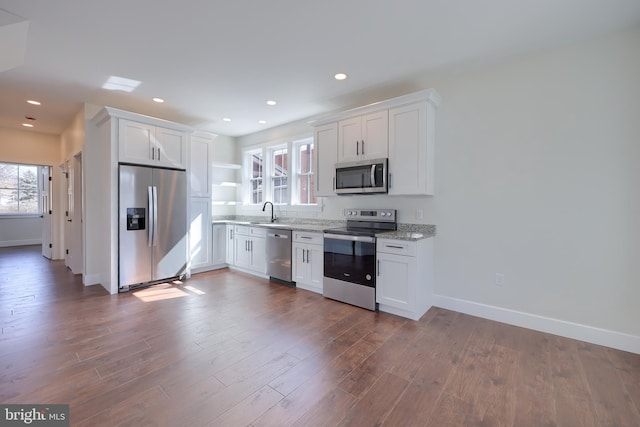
[376,253,417,311]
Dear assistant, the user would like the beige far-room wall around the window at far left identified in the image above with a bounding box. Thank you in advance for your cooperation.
[0,128,62,252]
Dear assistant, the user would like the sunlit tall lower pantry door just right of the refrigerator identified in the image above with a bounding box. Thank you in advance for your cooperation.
[189,198,212,269]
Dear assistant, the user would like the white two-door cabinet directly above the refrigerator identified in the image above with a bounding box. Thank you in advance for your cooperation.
[118,119,187,169]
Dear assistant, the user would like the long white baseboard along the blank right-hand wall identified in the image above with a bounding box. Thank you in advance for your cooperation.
[433,295,640,354]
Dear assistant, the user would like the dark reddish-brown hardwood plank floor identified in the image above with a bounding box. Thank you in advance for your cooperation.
[0,246,640,427]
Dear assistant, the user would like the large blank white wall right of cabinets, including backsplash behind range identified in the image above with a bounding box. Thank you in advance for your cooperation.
[235,27,640,352]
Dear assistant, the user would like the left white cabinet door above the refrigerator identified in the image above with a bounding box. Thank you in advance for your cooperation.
[118,119,155,165]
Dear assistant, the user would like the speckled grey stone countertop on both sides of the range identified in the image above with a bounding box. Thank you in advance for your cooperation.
[212,215,436,241]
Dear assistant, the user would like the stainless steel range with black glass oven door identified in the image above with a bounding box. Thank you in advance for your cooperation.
[322,209,397,310]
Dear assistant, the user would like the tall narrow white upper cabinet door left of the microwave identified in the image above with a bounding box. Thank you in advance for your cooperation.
[314,123,338,196]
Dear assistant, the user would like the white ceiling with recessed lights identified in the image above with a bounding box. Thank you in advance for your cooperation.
[0,0,640,136]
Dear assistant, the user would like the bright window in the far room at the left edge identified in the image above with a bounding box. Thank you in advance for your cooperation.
[0,163,40,215]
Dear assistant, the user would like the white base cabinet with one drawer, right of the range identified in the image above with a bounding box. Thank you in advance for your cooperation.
[376,238,433,320]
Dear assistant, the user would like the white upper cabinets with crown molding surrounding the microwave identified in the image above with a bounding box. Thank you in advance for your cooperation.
[311,89,441,196]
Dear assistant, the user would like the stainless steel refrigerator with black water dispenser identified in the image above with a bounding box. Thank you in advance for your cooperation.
[118,165,187,292]
